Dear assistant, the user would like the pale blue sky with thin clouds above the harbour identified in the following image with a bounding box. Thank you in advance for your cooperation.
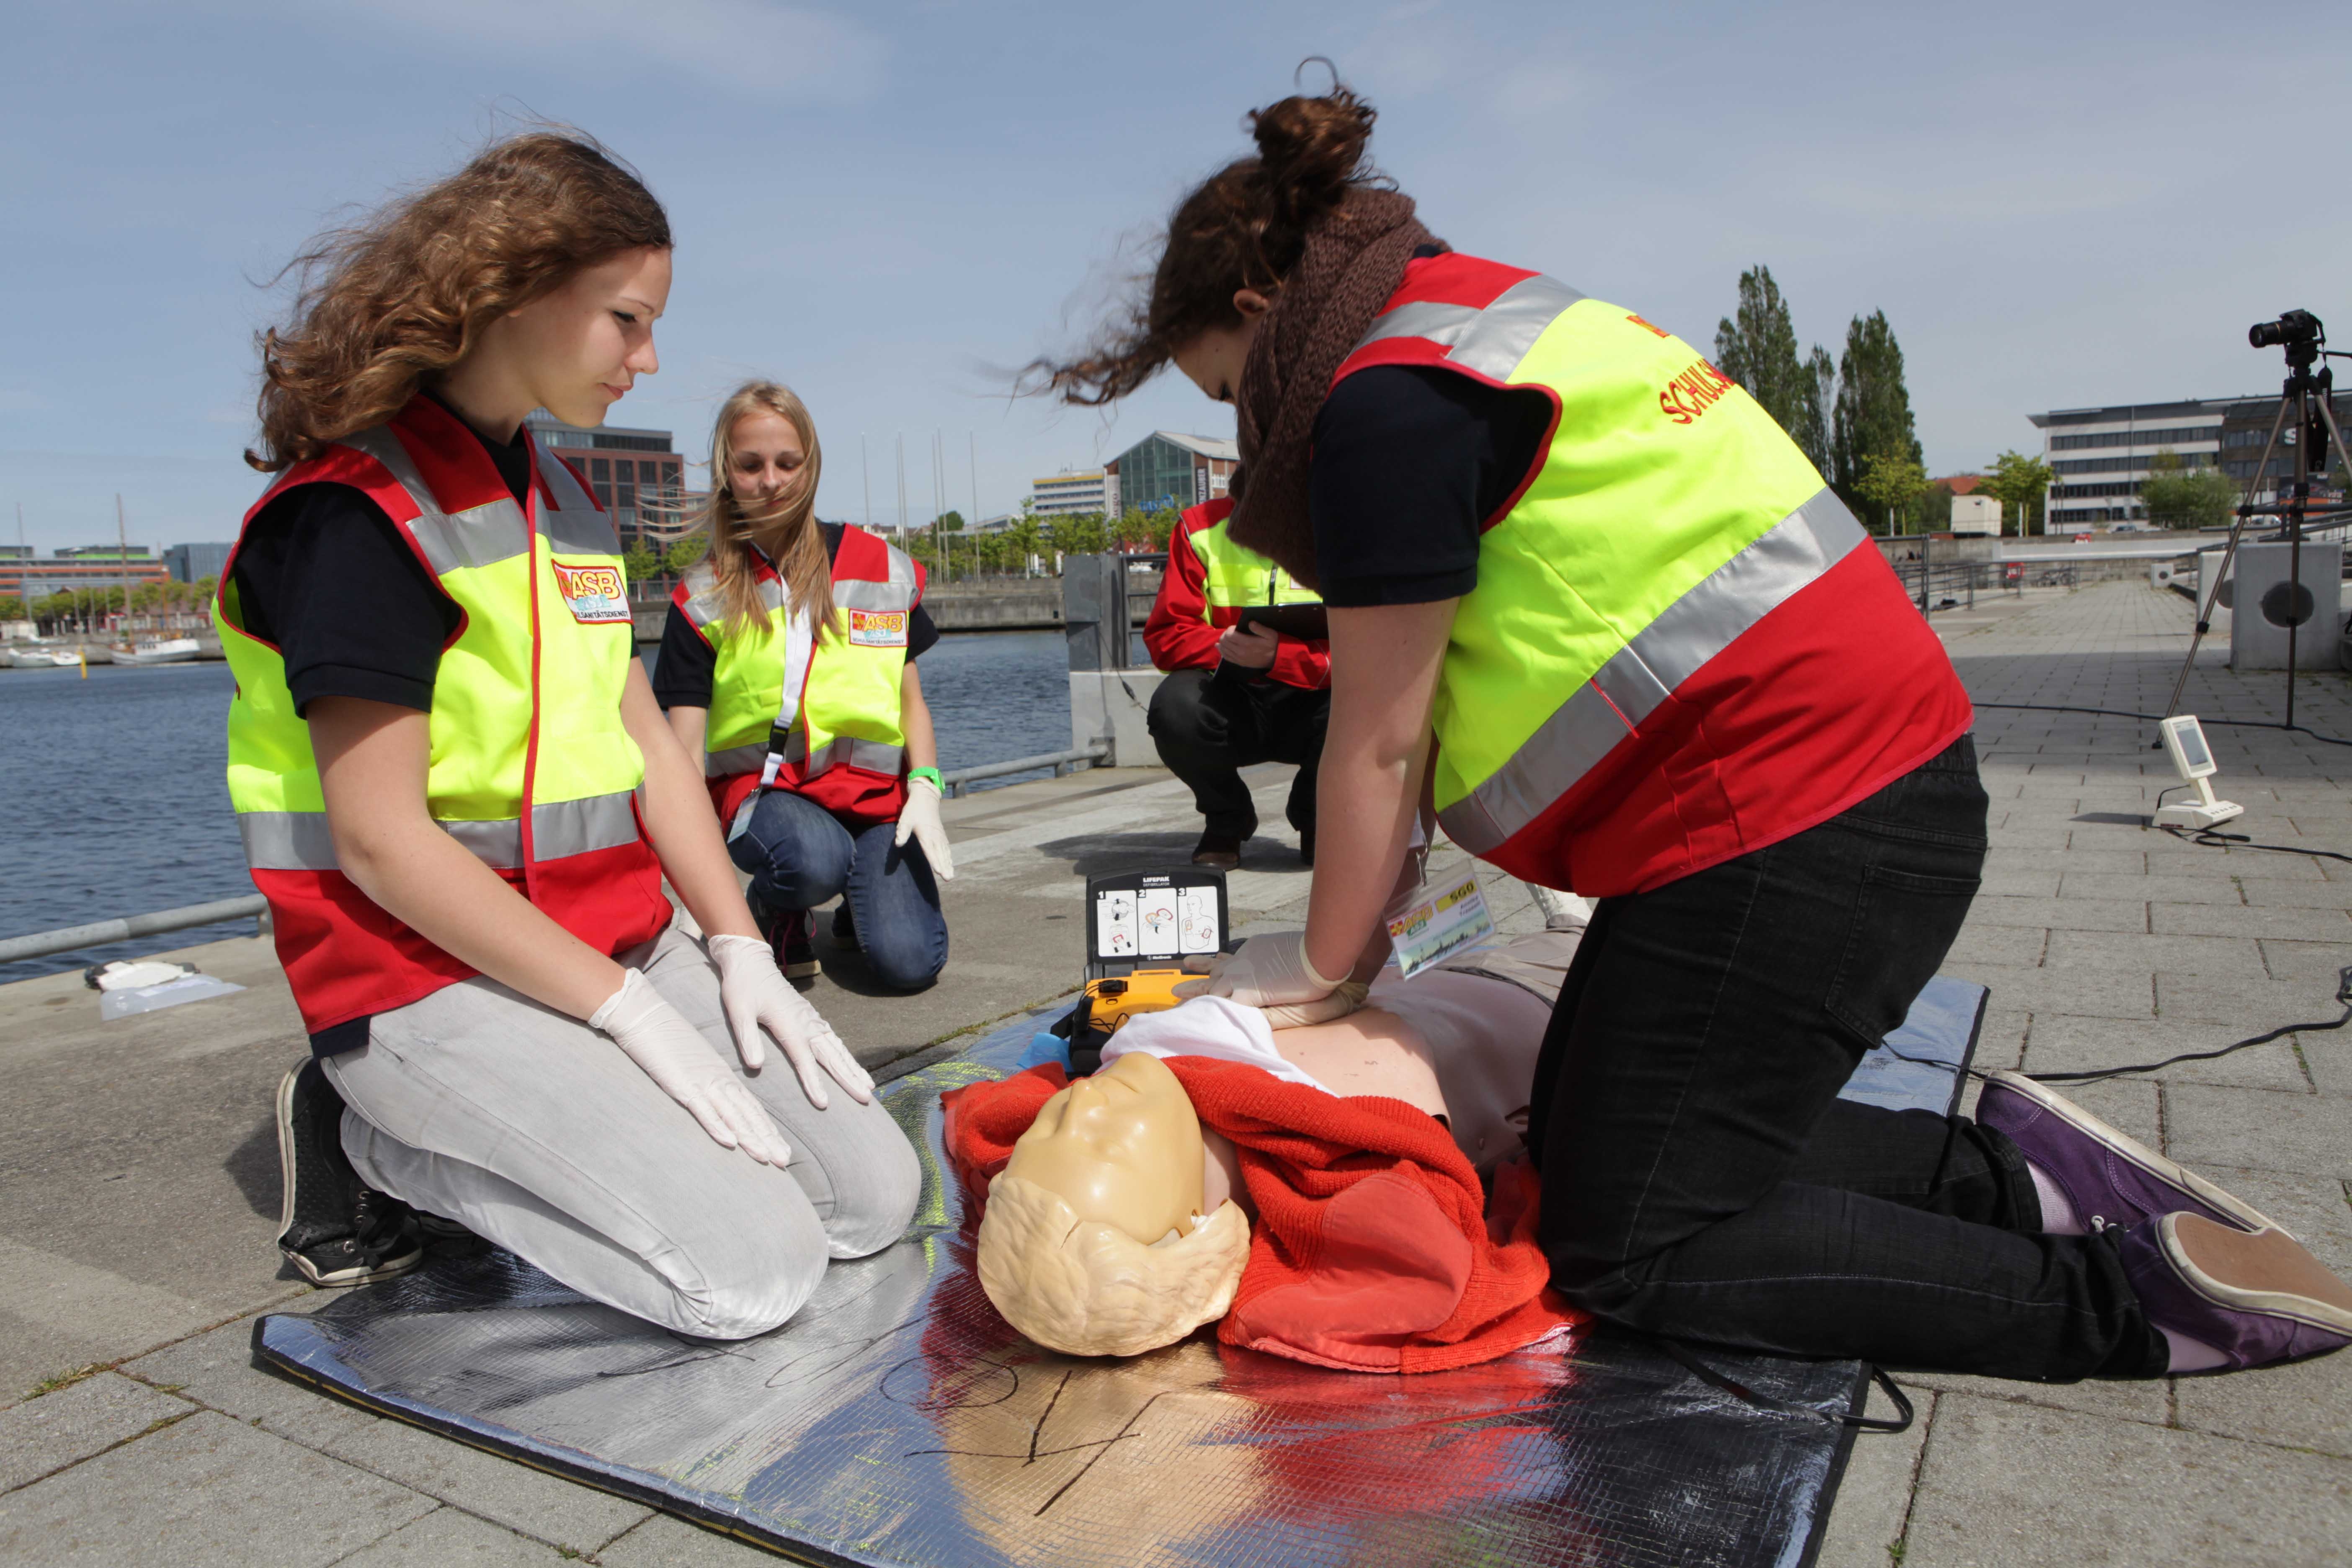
[0,0,2352,550]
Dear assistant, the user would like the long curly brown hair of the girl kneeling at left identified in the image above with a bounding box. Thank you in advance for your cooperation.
[245,129,671,472]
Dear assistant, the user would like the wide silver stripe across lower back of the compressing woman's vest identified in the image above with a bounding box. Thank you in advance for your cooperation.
[1437,489,1865,856]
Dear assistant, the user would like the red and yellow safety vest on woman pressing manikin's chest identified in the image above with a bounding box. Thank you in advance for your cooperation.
[1333,254,1973,896]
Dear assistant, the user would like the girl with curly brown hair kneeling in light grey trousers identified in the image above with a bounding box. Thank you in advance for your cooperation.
[219,132,917,1338]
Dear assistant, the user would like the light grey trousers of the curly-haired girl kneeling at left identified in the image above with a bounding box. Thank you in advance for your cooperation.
[322,924,922,1340]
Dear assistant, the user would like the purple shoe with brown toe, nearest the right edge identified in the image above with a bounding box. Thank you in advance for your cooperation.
[2117,1213,2352,1370]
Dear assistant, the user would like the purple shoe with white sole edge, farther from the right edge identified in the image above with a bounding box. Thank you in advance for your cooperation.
[1975,1072,2293,1241]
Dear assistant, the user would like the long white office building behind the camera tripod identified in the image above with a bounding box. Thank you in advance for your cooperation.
[2027,392,2352,534]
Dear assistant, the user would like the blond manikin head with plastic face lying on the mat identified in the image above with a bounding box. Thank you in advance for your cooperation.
[981,1051,1249,1357]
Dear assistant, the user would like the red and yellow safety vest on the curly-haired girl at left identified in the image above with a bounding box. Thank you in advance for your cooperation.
[214,397,671,1034]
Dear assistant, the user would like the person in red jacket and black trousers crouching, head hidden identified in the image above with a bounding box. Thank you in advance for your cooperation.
[1143,498,1331,870]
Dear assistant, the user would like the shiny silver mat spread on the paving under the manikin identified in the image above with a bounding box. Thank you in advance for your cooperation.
[254,980,1983,1568]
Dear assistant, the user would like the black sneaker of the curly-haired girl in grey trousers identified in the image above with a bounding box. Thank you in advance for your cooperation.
[278,1058,423,1286]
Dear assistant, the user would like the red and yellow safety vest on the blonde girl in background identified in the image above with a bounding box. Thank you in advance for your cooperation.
[673,524,924,823]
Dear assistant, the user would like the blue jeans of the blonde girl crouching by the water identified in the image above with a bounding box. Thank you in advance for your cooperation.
[727,790,948,990]
